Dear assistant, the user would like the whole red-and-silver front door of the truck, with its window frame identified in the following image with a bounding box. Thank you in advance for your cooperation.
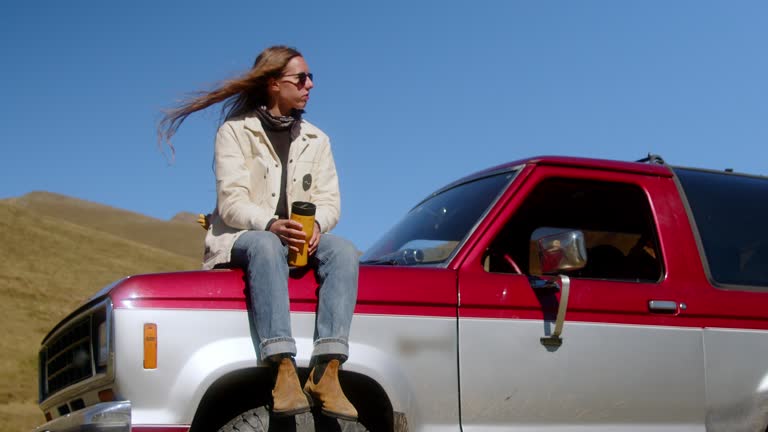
[459,167,705,431]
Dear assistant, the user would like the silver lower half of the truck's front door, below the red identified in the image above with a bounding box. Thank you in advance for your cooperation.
[461,319,704,431]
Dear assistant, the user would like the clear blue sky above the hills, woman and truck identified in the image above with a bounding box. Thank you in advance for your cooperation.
[0,1,768,249]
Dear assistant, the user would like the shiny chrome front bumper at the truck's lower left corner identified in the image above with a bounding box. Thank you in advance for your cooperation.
[33,401,131,432]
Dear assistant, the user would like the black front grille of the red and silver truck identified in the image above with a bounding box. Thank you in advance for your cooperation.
[40,303,108,401]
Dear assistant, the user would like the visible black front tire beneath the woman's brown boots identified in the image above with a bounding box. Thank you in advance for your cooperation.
[218,407,368,432]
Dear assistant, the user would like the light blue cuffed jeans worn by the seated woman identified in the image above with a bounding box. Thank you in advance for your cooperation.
[232,231,359,361]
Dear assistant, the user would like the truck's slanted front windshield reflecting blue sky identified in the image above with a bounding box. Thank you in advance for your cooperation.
[361,171,517,265]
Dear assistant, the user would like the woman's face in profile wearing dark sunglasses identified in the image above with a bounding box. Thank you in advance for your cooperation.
[270,57,315,115]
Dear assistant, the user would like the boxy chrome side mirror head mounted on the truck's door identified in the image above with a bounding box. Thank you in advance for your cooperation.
[533,230,587,274]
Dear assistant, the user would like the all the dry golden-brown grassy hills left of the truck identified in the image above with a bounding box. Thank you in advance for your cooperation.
[0,192,204,431]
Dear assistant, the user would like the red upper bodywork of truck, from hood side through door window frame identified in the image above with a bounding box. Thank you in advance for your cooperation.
[110,158,768,330]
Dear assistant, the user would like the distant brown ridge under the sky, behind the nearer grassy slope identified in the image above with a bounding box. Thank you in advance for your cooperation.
[6,192,205,262]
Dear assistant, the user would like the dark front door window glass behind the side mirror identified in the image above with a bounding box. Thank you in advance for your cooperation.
[484,178,662,282]
